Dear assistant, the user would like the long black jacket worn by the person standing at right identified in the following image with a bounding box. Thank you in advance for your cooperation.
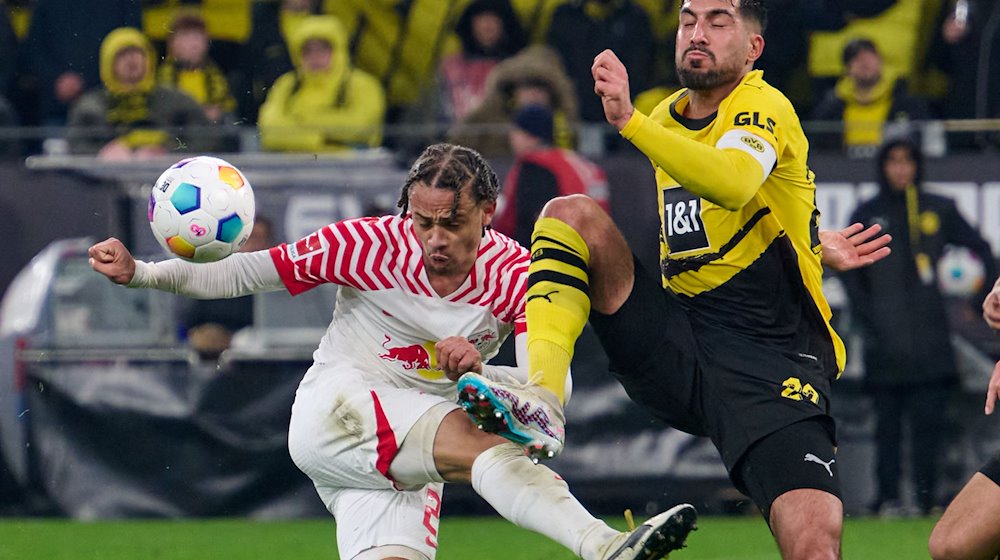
[841,188,996,387]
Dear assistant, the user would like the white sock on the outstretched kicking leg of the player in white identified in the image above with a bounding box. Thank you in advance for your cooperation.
[472,443,619,559]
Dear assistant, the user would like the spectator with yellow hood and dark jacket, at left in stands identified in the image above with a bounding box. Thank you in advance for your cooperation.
[66,27,216,160]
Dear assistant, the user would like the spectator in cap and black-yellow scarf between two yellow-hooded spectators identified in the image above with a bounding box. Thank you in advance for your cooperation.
[157,11,236,124]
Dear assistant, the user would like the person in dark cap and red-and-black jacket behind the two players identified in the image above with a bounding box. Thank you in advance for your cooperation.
[493,104,610,247]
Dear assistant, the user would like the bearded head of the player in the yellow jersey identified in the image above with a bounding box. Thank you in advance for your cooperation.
[674,0,764,90]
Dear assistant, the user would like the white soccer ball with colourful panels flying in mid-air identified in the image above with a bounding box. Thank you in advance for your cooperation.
[148,156,255,263]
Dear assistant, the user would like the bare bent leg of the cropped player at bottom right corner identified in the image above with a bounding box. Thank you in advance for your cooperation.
[928,472,1000,560]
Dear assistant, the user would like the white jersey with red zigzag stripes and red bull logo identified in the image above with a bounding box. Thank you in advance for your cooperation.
[271,216,529,397]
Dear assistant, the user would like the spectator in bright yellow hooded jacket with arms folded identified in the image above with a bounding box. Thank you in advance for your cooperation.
[258,16,386,152]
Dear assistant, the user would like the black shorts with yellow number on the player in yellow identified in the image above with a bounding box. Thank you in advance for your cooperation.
[590,260,833,477]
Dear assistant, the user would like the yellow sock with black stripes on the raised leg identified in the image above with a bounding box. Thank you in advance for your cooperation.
[525,214,590,402]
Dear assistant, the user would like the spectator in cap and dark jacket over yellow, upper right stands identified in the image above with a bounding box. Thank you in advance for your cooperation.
[812,38,927,157]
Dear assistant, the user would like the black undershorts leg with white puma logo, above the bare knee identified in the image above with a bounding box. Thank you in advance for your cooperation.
[730,416,841,524]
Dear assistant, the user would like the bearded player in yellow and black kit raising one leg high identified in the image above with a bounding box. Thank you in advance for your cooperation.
[459,0,889,559]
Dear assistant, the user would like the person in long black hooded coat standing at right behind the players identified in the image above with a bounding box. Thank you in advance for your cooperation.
[842,139,996,516]
